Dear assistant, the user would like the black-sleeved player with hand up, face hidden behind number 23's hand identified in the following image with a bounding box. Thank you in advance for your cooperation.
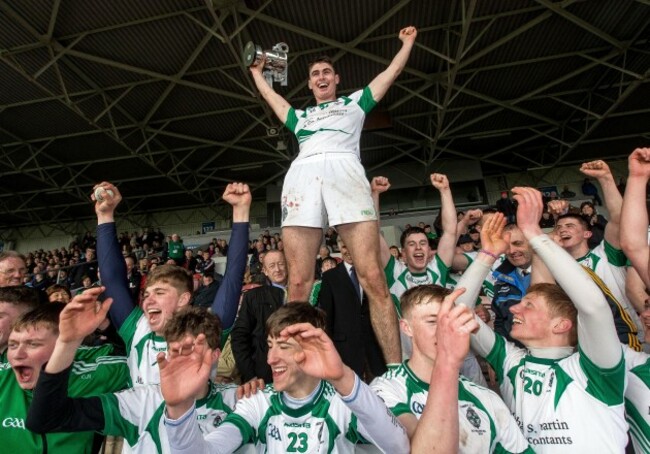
[27,301,237,454]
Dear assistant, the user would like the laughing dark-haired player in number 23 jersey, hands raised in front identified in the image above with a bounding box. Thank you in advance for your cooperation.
[159,303,409,454]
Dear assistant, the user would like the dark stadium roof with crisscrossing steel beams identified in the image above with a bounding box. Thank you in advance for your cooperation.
[0,0,650,228]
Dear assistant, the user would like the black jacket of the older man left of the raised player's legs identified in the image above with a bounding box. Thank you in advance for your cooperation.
[230,285,284,383]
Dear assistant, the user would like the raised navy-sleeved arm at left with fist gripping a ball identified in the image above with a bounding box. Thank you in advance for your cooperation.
[91,181,135,331]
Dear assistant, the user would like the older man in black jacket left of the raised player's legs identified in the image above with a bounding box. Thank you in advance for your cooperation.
[230,250,287,383]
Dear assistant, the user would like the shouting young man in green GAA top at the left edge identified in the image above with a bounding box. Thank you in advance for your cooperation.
[0,288,128,453]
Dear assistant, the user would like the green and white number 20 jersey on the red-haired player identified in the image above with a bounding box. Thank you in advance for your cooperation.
[485,333,627,453]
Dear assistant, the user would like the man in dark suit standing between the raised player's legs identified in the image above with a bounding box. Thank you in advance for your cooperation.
[318,237,386,381]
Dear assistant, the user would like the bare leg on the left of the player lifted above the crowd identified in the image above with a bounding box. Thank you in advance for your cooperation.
[282,226,323,301]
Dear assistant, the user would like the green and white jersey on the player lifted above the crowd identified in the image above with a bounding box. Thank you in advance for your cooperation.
[286,87,377,161]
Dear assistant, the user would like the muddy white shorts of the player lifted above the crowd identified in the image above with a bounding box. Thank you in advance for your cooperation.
[282,153,377,228]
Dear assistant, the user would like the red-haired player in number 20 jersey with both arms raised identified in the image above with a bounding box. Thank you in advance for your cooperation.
[458,188,627,453]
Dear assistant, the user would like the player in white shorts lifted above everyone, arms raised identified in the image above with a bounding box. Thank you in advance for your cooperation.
[246,27,417,363]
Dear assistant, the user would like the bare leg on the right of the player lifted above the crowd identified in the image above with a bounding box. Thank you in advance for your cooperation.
[336,221,402,364]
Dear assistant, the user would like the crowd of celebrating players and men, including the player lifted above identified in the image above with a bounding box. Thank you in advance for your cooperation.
[0,27,650,453]
